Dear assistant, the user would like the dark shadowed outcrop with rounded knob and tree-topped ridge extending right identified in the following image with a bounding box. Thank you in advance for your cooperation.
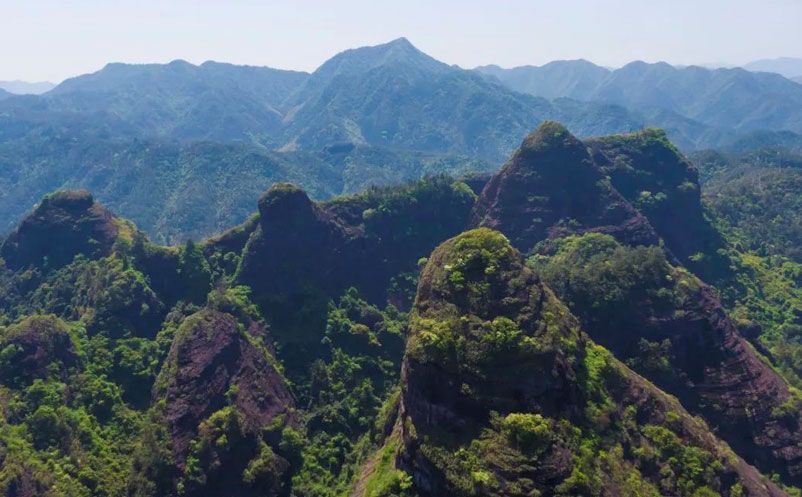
[236,178,476,377]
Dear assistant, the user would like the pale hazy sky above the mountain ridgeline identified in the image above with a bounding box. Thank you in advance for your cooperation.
[0,0,802,82]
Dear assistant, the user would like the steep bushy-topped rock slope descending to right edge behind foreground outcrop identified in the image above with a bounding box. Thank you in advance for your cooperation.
[533,234,802,486]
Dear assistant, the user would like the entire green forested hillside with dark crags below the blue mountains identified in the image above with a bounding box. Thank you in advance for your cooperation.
[0,122,802,497]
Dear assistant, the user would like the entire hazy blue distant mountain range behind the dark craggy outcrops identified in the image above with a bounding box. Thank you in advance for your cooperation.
[0,38,802,242]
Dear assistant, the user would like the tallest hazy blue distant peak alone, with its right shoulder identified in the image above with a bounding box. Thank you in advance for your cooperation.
[285,38,641,160]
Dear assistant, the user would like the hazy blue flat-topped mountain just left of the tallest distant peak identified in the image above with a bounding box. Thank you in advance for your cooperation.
[23,61,306,145]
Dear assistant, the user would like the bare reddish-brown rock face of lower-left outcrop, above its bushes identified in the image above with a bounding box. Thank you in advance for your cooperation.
[154,310,294,465]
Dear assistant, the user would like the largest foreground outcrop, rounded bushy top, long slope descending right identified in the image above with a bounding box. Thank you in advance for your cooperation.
[397,229,786,497]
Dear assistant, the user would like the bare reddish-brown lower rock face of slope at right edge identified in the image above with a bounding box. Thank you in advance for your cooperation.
[585,282,802,485]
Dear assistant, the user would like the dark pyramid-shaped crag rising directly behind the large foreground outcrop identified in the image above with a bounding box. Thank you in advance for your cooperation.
[472,121,658,252]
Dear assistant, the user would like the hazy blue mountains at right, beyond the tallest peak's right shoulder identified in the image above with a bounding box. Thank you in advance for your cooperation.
[479,61,802,146]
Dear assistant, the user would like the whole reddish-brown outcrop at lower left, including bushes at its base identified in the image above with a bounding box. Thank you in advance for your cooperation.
[153,302,298,495]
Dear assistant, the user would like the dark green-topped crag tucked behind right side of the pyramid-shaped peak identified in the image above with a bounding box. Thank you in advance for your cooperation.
[585,129,727,281]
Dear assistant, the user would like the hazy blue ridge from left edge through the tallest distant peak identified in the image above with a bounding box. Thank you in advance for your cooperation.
[0,38,643,161]
